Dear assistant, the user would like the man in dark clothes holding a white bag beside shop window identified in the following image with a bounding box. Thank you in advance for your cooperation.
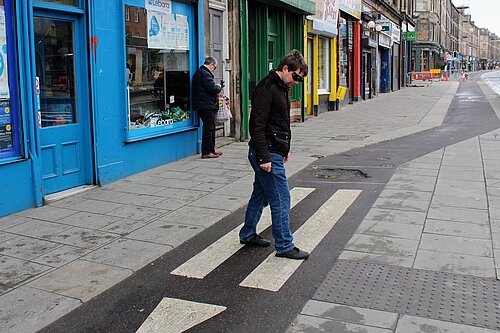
[193,57,223,158]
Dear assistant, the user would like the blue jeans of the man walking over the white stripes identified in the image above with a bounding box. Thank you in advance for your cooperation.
[240,148,294,253]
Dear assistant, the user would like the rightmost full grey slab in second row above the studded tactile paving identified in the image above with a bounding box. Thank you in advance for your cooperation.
[419,233,493,257]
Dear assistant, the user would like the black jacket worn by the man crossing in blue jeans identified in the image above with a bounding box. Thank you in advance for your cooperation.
[248,70,292,164]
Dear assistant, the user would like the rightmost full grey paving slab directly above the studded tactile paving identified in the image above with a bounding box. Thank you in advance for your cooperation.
[413,249,495,278]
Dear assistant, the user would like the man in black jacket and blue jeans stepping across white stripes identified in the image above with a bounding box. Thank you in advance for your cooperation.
[240,50,309,259]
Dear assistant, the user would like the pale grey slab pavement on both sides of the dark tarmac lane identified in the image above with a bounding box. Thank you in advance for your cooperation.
[0,78,500,332]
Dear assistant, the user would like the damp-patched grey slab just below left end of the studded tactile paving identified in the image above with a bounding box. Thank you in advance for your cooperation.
[301,300,398,329]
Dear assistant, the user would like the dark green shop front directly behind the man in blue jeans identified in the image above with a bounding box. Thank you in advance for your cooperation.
[240,0,315,138]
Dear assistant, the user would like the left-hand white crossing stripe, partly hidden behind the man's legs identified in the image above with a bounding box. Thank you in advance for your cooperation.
[170,187,314,279]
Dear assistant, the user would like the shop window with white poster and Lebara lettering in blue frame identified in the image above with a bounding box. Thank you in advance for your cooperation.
[125,5,193,137]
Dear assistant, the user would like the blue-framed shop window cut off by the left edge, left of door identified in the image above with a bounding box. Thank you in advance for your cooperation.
[0,0,22,162]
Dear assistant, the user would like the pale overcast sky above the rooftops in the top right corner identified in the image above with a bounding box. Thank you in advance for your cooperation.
[453,0,500,37]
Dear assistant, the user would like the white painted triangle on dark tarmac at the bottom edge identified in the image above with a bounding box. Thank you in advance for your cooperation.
[136,297,226,333]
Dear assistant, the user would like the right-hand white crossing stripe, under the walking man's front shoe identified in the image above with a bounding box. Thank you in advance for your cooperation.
[240,190,361,291]
